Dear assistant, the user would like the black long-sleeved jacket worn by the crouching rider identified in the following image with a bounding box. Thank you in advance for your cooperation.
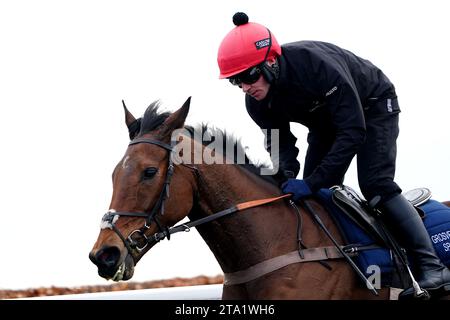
[246,41,399,191]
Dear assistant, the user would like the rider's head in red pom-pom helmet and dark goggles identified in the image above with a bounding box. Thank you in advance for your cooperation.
[217,12,281,100]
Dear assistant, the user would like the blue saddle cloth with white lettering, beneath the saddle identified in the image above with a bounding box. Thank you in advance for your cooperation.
[318,189,450,285]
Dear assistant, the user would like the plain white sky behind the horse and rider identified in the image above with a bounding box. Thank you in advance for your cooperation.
[0,0,450,289]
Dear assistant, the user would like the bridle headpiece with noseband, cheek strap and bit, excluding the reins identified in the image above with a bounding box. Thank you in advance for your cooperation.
[102,138,174,256]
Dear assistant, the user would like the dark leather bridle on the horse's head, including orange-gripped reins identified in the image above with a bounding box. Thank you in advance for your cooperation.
[102,138,291,259]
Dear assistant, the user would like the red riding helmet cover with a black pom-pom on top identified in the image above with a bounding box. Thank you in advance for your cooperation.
[217,12,281,79]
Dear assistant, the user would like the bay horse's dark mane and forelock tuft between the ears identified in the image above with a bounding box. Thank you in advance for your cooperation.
[138,101,277,185]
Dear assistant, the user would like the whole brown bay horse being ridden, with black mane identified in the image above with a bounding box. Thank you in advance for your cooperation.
[89,98,389,300]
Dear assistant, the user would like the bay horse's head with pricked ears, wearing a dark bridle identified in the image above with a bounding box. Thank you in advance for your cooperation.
[89,98,194,281]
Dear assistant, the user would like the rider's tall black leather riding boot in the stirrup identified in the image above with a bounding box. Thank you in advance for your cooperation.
[380,194,450,299]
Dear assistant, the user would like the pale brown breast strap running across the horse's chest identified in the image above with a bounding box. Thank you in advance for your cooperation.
[223,246,356,286]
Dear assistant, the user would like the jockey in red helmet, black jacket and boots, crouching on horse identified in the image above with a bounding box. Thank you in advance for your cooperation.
[217,12,450,298]
